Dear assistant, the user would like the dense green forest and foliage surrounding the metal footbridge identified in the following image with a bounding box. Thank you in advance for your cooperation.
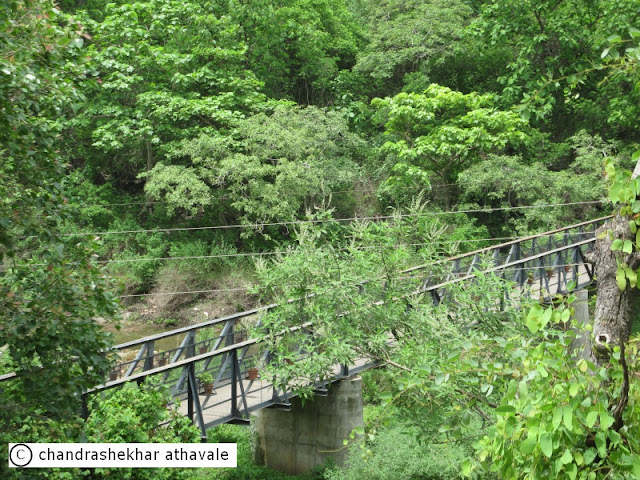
[0,0,640,480]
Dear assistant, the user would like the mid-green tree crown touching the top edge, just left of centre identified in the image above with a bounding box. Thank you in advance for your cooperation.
[230,0,361,105]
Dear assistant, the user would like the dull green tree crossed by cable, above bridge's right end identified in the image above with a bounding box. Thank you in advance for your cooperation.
[458,131,615,235]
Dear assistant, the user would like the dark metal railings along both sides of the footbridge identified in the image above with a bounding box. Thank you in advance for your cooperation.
[0,217,610,434]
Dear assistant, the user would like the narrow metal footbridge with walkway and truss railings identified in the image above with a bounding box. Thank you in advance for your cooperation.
[0,217,610,470]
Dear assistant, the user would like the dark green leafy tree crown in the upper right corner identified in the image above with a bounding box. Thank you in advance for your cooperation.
[476,0,639,138]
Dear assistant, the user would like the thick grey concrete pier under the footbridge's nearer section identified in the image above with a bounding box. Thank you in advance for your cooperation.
[251,377,364,475]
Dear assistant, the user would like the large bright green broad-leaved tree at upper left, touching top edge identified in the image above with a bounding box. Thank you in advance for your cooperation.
[75,0,263,190]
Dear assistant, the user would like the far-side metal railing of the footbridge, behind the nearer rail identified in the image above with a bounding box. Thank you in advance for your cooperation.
[97,217,609,396]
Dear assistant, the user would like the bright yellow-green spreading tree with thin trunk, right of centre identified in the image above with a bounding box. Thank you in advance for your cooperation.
[371,84,528,208]
